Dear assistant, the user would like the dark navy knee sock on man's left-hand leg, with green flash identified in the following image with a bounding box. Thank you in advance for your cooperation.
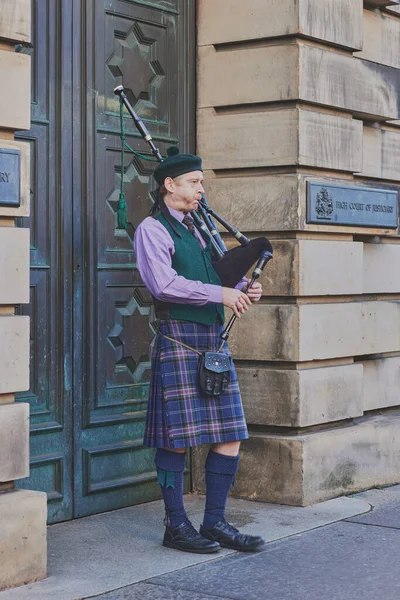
[154,448,187,527]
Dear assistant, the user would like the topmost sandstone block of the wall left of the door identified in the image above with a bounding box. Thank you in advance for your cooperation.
[0,0,31,42]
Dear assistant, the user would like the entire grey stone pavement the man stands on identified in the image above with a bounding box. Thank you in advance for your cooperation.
[0,485,400,600]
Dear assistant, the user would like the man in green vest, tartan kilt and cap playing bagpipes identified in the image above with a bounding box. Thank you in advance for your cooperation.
[134,149,264,553]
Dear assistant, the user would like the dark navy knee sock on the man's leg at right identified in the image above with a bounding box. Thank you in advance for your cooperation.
[203,450,239,529]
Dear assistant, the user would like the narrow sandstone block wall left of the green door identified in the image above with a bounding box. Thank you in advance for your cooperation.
[0,0,47,590]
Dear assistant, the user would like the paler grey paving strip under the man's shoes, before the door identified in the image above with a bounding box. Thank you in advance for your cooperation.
[0,494,371,600]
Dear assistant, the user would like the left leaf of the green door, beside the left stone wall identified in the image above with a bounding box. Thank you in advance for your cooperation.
[17,0,73,522]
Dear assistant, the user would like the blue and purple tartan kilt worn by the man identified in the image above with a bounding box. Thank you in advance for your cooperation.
[144,319,248,448]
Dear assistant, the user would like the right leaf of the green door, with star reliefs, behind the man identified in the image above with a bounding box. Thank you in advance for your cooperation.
[74,0,194,516]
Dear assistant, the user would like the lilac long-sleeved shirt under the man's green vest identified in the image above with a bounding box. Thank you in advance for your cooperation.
[134,208,222,306]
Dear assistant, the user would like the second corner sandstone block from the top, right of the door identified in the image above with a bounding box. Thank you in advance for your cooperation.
[199,42,400,119]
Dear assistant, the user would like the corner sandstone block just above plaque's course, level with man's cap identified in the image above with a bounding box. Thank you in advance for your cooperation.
[198,108,362,172]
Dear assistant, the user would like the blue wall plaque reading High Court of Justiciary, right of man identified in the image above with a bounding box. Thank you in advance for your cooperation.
[307,181,399,229]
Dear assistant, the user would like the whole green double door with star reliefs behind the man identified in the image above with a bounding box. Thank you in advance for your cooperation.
[20,0,195,522]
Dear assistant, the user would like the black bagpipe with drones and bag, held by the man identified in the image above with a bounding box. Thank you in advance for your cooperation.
[114,85,273,340]
